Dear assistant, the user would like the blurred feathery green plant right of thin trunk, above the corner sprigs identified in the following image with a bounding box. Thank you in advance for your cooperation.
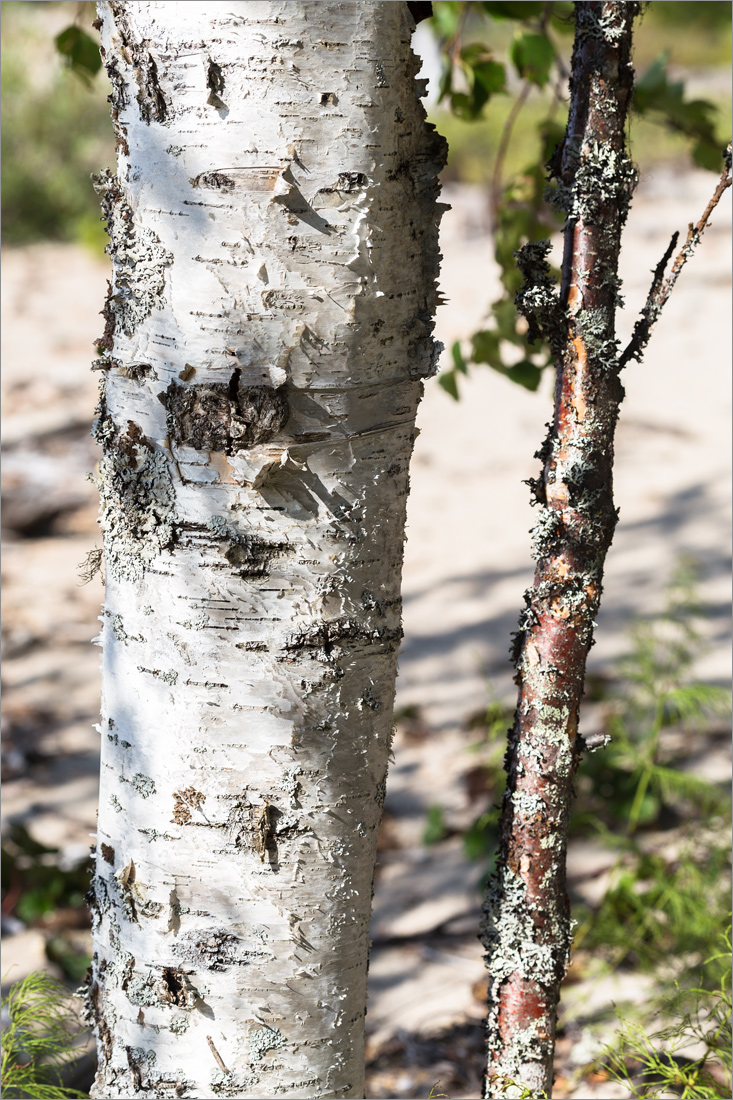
[571,567,730,980]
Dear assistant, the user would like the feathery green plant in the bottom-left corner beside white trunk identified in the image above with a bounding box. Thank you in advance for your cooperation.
[0,970,87,1100]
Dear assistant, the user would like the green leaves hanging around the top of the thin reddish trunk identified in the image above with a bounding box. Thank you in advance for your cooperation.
[424,0,730,399]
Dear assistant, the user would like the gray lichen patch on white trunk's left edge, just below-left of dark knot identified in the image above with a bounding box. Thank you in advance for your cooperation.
[97,437,175,581]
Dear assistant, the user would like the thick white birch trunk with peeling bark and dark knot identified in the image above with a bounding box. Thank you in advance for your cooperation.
[82,0,445,1098]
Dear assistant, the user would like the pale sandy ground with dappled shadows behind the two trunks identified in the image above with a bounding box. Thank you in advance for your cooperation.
[2,172,731,1100]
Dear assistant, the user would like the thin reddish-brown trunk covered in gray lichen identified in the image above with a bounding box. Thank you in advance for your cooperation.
[482,2,639,1097]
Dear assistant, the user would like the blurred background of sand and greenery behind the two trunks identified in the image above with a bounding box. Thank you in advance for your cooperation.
[2,0,731,1098]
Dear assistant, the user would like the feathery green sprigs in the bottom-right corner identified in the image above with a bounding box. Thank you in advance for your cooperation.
[604,932,732,1100]
